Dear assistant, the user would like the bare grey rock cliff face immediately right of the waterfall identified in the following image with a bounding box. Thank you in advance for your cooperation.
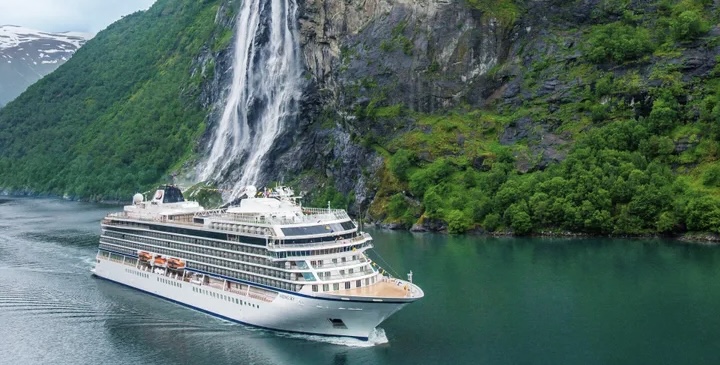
[258,0,513,213]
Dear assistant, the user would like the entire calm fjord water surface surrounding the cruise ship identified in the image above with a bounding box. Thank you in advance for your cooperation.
[0,197,720,365]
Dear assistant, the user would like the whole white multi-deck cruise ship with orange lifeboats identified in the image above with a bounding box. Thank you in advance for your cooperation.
[93,185,424,340]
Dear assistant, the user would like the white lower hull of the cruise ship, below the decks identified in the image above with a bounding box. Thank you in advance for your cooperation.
[94,259,408,340]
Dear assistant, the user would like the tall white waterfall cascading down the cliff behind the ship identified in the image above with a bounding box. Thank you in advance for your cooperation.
[200,0,302,199]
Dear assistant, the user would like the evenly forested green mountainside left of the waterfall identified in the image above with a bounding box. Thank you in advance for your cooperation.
[0,0,231,199]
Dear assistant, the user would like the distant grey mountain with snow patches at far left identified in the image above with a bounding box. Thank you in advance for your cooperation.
[0,25,91,106]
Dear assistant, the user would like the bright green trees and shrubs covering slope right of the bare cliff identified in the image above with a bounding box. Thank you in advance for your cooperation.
[366,0,720,235]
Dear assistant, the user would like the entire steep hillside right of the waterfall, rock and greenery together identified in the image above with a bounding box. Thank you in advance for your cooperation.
[290,0,720,234]
